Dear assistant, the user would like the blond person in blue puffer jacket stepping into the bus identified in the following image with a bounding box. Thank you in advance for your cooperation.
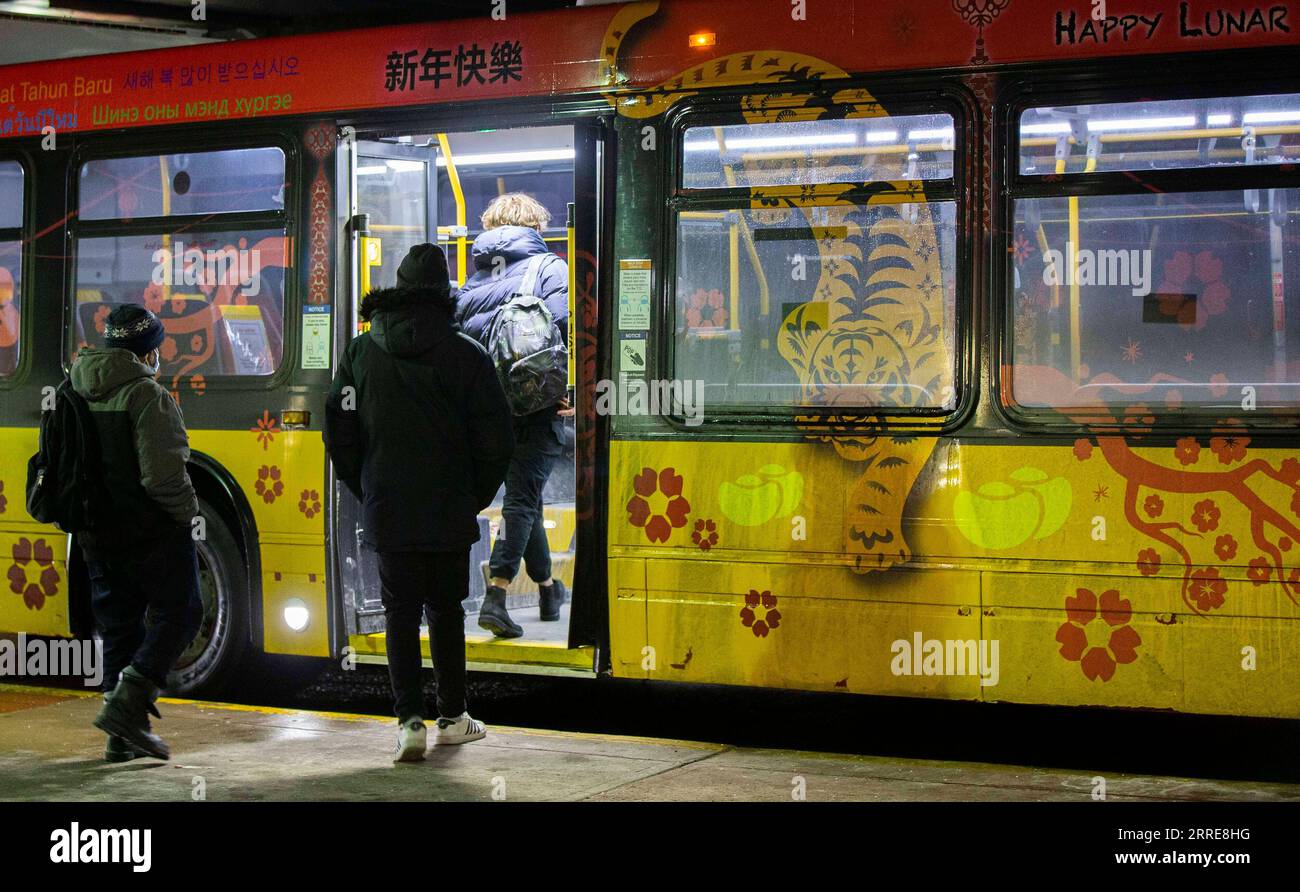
[455,192,573,638]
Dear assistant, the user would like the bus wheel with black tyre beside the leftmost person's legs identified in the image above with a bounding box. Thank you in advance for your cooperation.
[168,499,248,697]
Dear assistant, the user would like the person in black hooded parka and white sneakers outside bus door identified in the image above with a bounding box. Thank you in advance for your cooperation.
[325,244,515,762]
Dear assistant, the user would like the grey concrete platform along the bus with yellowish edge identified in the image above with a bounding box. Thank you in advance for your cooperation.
[0,685,1300,802]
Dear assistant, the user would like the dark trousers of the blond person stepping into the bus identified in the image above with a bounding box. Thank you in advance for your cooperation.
[488,419,563,583]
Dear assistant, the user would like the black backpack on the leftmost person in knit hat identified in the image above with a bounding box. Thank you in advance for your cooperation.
[27,378,107,533]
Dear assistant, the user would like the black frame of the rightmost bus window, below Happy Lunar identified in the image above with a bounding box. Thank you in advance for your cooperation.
[989,63,1300,437]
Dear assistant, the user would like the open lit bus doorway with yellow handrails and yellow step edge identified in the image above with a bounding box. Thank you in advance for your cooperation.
[334,124,602,675]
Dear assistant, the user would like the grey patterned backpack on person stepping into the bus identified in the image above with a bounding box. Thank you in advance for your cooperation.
[486,254,568,415]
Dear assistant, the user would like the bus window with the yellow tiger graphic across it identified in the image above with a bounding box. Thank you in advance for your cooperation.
[672,108,957,413]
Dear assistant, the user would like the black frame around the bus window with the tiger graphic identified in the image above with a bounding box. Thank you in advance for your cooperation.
[660,81,983,437]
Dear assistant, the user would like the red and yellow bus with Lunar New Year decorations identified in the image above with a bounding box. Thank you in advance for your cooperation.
[0,0,1300,716]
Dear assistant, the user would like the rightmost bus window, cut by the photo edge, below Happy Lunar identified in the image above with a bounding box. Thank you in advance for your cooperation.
[1008,96,1300,417]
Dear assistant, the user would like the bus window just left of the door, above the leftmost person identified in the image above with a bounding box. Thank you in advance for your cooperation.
[69,148,293,381]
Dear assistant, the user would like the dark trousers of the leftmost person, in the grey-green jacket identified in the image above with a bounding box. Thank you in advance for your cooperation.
[86,527,203,690]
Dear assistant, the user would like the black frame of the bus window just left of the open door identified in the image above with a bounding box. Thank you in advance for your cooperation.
[60,130,303,393]
